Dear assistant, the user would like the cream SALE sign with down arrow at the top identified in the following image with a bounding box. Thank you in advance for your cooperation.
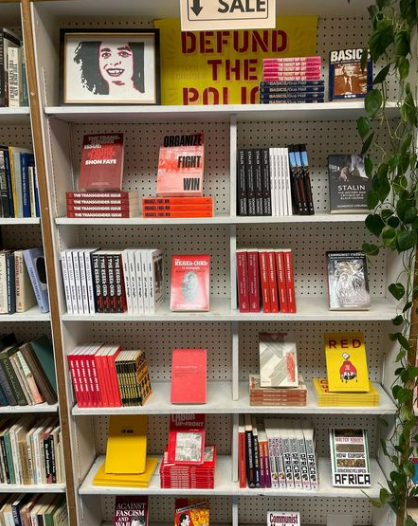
[180,0,276,31]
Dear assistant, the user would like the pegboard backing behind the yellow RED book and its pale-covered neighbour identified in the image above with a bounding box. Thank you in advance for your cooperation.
[239,322,387,382]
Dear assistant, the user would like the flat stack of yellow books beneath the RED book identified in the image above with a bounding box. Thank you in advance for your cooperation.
[312,378,380,407]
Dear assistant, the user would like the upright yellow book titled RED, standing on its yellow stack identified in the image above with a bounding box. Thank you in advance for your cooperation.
[324,332,370,393]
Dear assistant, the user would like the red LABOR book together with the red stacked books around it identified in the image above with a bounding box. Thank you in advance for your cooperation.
[160,414,216,489]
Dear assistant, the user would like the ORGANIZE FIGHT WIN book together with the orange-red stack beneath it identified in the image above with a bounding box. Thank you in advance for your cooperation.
[142,133,213,218]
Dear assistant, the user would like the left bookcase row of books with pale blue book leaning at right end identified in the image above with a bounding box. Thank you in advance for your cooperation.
[0,248,49,314]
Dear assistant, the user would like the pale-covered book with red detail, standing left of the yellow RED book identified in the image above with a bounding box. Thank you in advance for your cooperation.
[259,332,299,387]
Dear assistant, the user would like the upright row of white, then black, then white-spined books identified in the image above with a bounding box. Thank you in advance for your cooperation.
[60,248,164,315]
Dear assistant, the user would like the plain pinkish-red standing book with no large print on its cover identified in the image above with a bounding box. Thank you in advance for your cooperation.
[171,349,207,404]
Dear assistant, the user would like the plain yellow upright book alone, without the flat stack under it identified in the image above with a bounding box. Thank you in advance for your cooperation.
[105,415,148,475]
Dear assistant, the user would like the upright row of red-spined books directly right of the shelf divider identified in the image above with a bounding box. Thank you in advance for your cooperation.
[236,248,296,314]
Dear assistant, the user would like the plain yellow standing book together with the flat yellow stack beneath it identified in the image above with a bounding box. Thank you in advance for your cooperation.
[93,415,158,488]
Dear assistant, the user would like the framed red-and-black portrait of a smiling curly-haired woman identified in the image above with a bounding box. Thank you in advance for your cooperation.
[60,29,160,104]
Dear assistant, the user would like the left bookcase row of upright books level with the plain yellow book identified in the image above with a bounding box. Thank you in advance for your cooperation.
[0,415,65,485]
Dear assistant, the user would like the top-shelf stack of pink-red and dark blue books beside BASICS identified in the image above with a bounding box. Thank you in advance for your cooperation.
[260,56,324,104]
